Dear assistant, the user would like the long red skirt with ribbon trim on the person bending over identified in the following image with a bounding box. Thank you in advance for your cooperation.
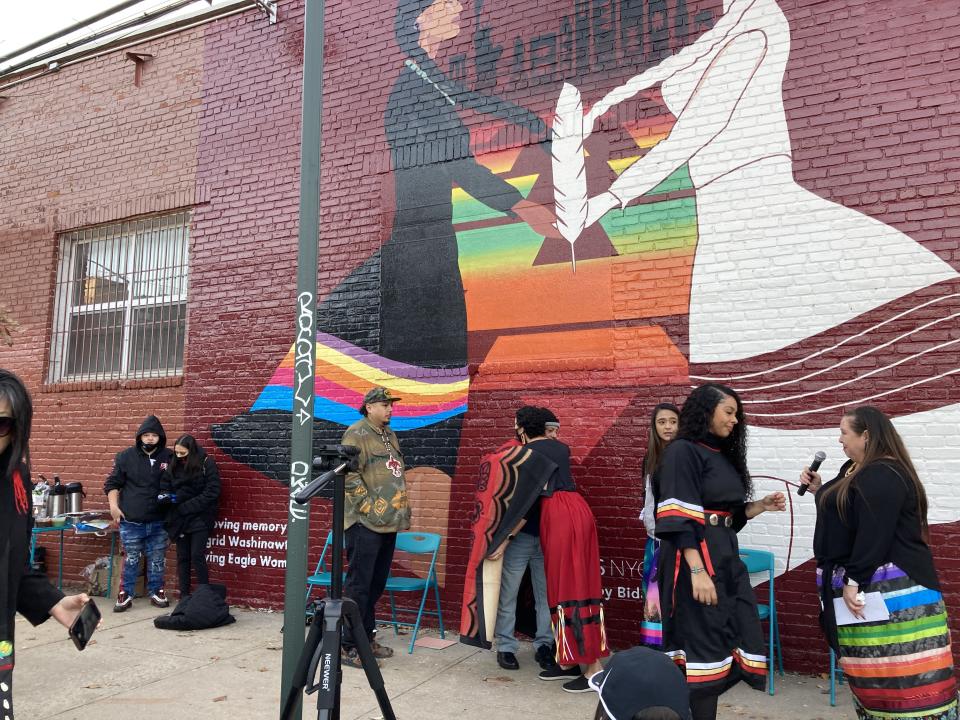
[540,492,609,665]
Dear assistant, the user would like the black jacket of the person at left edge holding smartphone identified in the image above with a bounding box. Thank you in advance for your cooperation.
[0,448,63,673]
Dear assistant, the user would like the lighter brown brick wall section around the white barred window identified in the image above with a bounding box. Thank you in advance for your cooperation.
[0,30,209,582]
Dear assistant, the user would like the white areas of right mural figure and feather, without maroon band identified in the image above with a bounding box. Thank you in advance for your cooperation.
[553,0,960,570]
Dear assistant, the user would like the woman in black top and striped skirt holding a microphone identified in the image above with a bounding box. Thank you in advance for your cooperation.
[800,406,957,720]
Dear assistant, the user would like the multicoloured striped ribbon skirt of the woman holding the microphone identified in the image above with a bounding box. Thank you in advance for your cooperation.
[820,563,957,720]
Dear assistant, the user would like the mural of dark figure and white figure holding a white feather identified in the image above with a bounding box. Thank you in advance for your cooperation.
[213,0,960,612]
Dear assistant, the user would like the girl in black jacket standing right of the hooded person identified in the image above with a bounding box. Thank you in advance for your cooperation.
[162,435,220,599]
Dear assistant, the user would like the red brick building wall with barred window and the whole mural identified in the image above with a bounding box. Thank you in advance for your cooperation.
[0,0,960,669]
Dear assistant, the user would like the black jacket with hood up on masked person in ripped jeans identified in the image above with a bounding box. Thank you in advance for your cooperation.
[103,415,173,522]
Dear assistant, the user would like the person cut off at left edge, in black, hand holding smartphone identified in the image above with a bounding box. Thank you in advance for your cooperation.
[0,369,90,720]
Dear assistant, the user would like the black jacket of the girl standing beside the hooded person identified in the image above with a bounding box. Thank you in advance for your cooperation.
[161,449,220,539]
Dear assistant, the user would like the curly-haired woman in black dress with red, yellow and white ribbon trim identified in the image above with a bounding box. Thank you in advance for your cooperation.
[654,384,786,720]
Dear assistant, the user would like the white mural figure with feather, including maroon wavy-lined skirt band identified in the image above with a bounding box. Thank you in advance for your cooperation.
[553,0,960,566]
